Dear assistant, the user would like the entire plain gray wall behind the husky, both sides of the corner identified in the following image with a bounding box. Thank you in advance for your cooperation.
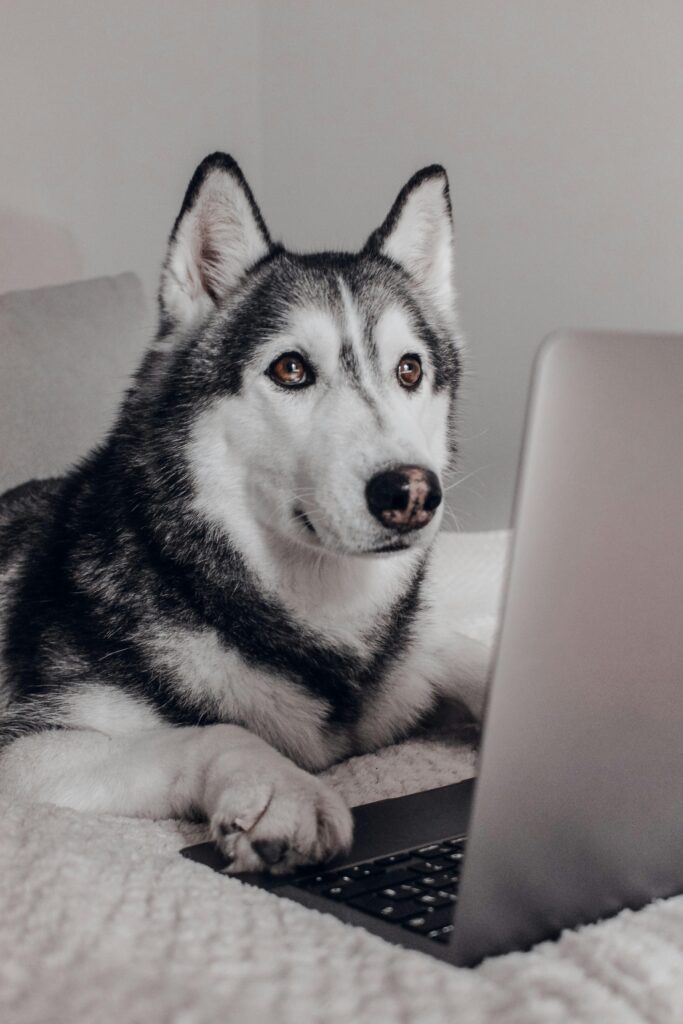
[0,0,683,529]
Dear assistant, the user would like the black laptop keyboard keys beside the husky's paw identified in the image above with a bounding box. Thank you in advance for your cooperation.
[294,836,465,942]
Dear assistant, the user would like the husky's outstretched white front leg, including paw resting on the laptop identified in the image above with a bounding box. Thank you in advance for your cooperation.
[0,725,352,873]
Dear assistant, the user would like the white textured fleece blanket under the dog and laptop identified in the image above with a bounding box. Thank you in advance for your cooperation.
[0,534,683,1024]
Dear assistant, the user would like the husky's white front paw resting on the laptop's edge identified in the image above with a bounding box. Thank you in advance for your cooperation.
[211,766,353,874]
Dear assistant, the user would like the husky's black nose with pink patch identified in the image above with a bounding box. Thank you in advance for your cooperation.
[366,466,442,534]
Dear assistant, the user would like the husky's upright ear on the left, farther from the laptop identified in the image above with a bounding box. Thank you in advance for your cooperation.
[159,153,270,333]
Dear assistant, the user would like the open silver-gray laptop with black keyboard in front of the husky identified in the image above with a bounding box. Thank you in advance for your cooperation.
[183,333,683,965]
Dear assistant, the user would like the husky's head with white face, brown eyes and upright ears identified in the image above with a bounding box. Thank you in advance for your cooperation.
[157,154,459,555]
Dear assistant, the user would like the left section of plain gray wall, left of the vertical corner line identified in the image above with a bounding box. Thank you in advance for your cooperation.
[0,0,262,315]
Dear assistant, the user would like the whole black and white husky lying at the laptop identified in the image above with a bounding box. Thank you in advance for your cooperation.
[0,154,487,873]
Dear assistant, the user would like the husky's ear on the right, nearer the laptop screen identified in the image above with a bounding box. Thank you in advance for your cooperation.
[366,164,456,325]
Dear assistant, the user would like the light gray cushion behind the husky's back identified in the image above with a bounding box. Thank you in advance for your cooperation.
[0,273,151,493]
